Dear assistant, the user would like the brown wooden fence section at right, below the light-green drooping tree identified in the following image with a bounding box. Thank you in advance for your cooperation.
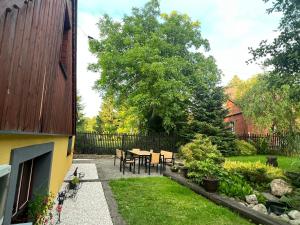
[238,134,300,153]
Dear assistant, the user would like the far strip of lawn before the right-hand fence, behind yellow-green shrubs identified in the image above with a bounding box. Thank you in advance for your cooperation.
[227,155,300,171]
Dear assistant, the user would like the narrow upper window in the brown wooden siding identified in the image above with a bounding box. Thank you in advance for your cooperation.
[59,7,71,79]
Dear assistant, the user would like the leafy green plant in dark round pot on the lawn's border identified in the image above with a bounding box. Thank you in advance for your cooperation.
[188,159,222,192]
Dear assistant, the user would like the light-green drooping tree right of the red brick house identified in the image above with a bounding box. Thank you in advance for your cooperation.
[237,75,300,134]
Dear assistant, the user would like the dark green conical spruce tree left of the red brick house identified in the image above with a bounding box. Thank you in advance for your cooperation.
[183,59,236,155]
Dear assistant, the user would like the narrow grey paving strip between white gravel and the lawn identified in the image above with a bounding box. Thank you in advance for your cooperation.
[101,181,126,225]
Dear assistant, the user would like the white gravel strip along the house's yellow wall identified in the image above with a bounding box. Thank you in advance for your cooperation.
[53,163,113,225]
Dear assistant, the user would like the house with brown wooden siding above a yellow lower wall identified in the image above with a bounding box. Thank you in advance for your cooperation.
[0,0,77,225]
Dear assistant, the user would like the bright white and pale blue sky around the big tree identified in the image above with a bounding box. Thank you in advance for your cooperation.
[77,0,280,117]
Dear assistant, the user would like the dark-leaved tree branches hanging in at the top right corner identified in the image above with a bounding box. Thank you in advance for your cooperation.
[250,0,300,101]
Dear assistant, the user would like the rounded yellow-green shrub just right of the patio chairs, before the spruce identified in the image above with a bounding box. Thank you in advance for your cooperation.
[180,134,224,163]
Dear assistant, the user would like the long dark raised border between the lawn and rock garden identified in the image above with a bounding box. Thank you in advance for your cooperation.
[163,171,289,225]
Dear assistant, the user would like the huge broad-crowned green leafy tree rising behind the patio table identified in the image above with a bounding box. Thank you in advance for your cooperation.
[89,0,215,132]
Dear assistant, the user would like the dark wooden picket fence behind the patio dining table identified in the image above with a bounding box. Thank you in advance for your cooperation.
[75,133,178,155]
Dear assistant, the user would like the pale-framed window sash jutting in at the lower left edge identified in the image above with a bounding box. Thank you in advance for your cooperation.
[0,165,11,225]
